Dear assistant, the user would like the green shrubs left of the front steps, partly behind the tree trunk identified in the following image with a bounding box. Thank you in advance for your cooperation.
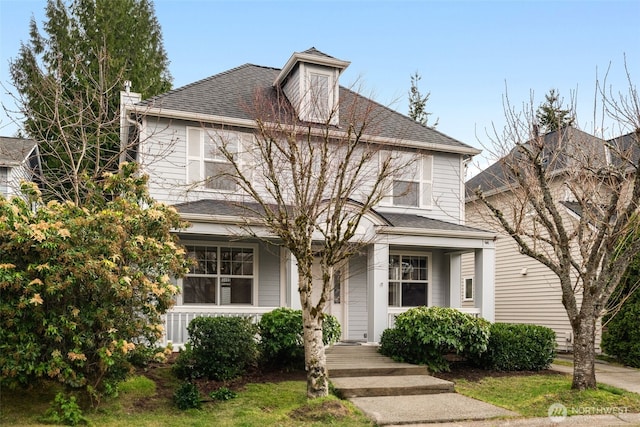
[173,308,340,381]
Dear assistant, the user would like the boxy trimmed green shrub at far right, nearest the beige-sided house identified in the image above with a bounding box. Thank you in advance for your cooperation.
[475,323,556,371]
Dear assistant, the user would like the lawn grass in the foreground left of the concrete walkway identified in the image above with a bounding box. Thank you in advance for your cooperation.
[0,369,374,427]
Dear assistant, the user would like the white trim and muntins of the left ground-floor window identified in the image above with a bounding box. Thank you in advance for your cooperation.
[176,240,260,308]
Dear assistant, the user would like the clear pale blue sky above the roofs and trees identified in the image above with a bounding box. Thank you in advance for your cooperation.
[0,0,640,174]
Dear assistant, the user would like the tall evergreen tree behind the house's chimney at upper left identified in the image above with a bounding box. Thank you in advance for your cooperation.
[10,0,171,202]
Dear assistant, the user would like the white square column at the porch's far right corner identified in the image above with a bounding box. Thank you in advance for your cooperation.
[474,247,496,322]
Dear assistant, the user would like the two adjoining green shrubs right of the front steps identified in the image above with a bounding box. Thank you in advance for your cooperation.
[380,307,556,372]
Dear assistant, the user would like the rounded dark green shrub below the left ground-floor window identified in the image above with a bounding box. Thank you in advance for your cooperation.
[173,317,258,381]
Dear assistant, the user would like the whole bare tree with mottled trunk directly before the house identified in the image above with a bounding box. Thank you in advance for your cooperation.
[210,85,398,397]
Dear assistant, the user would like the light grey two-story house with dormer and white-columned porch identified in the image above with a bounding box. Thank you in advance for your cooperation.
[121,48,495,345]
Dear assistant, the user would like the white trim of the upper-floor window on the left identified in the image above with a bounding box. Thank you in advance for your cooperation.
[185,126,242,194]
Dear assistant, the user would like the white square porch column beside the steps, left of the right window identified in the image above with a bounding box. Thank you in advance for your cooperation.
[367,243,389,342]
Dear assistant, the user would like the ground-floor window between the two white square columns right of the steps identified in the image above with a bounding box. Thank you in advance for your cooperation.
[389,254,429,307]
